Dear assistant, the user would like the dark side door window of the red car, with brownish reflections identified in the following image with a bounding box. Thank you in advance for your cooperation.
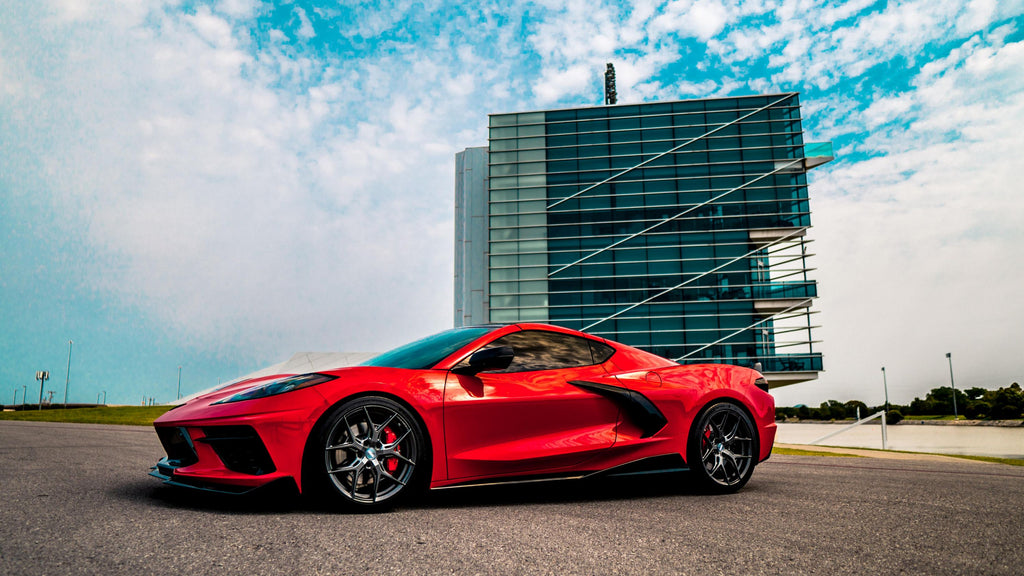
[487,330,602,372]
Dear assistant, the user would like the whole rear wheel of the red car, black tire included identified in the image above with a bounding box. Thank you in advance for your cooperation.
[686,402,758,494]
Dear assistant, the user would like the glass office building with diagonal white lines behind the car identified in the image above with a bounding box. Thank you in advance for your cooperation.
[455,93,831,385]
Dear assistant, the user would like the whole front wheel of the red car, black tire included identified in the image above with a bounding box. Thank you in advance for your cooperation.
[309,396,430,511]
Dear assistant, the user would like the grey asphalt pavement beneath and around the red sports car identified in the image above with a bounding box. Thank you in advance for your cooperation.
[0,421,1024,576]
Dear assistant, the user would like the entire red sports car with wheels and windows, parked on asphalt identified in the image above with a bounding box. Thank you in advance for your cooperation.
[151,324,775,508]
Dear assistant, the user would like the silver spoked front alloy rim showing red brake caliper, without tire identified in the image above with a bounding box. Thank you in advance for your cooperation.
[324,399,415,504]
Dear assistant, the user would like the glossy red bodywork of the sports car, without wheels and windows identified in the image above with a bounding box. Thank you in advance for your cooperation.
[153,324,775,492]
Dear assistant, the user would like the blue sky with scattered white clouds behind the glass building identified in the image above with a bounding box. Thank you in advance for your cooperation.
[0,0,1024,406]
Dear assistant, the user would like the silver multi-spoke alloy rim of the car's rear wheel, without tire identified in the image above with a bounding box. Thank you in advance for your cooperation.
[699,403,755,487]
